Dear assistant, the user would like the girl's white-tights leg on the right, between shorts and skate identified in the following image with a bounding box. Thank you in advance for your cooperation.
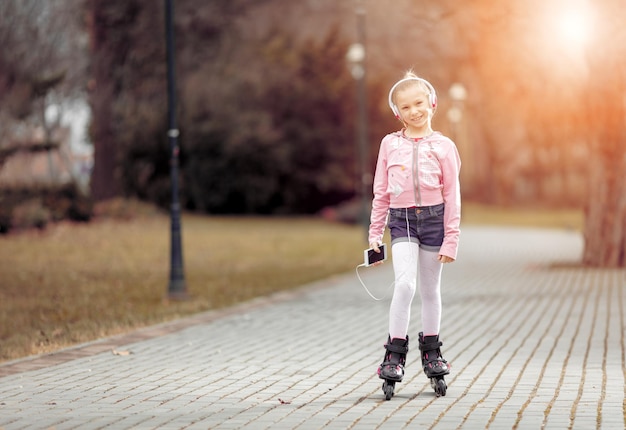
[419,249,443,336]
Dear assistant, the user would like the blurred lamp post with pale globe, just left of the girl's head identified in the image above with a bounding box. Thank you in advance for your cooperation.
[346,6,372,238]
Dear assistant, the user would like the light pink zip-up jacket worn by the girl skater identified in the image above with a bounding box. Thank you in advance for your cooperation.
[369,131,461,259]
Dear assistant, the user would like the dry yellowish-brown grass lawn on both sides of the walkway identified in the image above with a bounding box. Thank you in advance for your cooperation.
[0,200,582,362]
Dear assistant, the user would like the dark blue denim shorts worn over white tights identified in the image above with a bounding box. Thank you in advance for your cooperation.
[388,203,445,252]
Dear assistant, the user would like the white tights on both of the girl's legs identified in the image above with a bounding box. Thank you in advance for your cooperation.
[389,242,443,339]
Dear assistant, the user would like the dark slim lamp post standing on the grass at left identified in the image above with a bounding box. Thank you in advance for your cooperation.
[165,0,188,300]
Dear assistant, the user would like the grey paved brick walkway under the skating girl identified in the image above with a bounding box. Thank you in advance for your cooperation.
[0,227,626,430]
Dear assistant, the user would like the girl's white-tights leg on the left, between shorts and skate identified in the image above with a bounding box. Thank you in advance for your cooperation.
[389,242,419,340]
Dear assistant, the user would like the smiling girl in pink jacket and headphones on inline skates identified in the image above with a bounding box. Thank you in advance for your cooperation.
[369,72,461,399]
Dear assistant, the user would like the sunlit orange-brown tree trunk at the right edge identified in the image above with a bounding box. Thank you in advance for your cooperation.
[580,0,626,267]
